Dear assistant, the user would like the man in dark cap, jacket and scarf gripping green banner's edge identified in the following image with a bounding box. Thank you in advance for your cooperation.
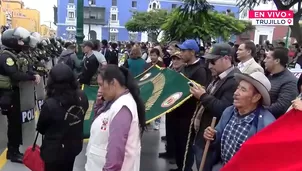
[190,43,240,169]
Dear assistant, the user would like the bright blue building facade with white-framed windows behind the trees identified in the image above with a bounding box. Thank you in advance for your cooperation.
[56,0,239,41]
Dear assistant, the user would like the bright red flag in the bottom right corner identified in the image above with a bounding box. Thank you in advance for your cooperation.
[220,109,302,171]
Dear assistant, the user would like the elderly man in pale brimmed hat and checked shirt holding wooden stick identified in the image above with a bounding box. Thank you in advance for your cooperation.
[193,72,275,171]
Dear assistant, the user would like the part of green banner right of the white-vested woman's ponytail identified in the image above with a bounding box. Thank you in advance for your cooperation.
[136,67,191,123]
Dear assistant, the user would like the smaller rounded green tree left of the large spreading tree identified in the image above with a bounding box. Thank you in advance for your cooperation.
[125,10,168,41]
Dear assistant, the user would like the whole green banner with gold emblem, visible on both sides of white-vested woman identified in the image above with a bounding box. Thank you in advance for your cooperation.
[83,66,191,138]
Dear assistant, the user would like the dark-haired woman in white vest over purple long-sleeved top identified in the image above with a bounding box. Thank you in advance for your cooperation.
[85,65,145,171]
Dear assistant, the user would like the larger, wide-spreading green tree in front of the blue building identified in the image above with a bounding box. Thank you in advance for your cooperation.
[162,0,252,41]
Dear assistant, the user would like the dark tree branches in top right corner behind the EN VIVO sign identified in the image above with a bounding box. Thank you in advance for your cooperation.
[238,0,302,45]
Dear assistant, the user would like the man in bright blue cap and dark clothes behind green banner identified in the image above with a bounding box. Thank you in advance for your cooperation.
[165,39,211,171]
